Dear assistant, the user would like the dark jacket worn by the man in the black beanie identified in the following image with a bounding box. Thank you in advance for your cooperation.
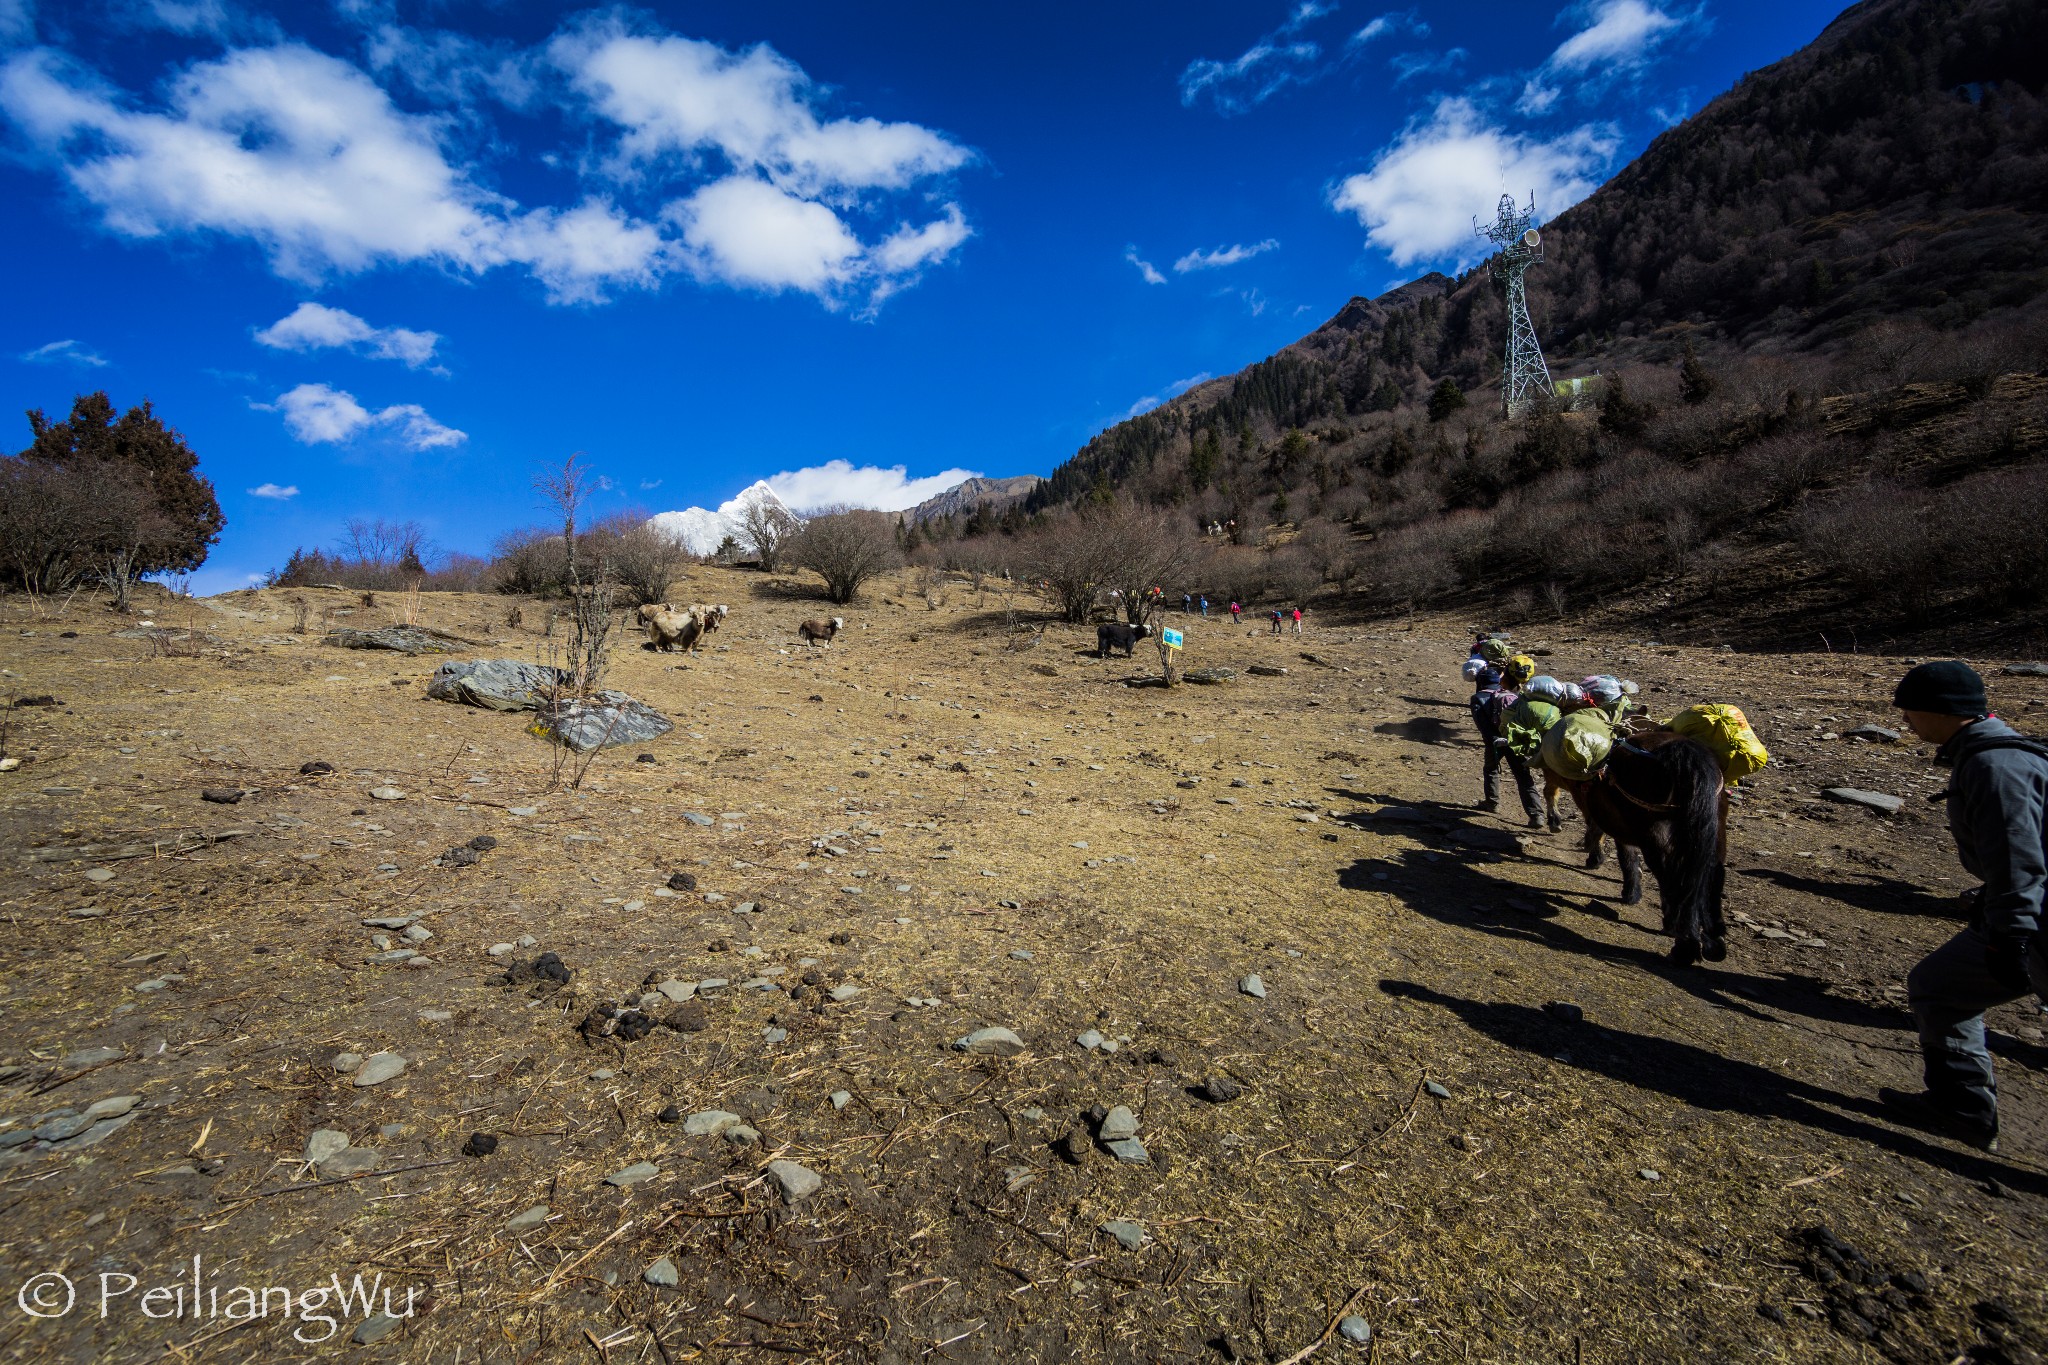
[1935,716,2048,945]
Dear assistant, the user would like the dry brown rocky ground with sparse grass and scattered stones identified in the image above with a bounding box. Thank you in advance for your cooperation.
[0,571,2048,1363]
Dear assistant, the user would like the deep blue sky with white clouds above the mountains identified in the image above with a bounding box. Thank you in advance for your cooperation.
[0,0,1835,591]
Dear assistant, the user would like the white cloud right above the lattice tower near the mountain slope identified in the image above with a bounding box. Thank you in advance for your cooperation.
[1331,98,1620,266]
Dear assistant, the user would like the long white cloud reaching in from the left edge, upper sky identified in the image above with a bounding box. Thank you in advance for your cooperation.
[0,45,659,301]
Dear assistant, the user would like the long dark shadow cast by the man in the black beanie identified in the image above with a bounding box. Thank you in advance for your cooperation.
[1380,980,2048,1193]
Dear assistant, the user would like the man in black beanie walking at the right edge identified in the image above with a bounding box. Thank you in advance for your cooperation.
[1878,659,2048,1152]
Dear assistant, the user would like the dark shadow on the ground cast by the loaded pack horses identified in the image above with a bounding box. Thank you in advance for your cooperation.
[1337,777,1913,1029]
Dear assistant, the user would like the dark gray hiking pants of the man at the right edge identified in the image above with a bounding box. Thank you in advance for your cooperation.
[1907,925,2048,1128]
